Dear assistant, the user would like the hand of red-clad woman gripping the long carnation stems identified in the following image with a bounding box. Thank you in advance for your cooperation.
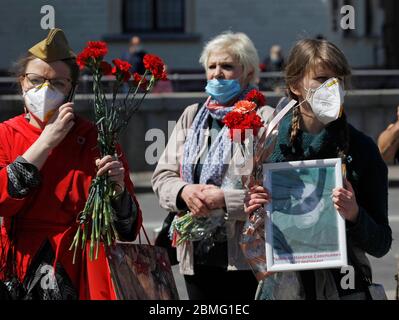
[96,155,125,193]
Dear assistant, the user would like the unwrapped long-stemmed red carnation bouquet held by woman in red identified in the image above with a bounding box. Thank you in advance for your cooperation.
[70,41,167,261]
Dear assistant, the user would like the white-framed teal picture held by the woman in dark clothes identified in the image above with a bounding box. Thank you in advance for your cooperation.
[263,158,347,271]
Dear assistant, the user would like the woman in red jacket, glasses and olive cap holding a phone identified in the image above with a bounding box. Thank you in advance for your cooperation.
[0,29,142,299]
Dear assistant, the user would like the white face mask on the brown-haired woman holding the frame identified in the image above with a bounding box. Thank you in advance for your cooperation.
[305,78,345,125]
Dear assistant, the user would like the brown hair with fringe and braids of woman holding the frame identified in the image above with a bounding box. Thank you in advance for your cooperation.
[284,39,351,161]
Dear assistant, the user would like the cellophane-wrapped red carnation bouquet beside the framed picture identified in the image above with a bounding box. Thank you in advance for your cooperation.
[227,95,296,283]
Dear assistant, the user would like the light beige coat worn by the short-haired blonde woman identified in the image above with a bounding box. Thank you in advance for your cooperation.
[152,104,274,275]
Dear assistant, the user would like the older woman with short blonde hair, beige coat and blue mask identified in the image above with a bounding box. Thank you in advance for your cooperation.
[152,32,273,299]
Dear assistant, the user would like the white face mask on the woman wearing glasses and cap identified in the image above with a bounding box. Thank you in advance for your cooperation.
[23,82,66,123]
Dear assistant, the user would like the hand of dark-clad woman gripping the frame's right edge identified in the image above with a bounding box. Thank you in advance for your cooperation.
[332,178,359,222]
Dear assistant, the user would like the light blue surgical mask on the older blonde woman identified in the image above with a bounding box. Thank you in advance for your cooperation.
[205,79,241,104]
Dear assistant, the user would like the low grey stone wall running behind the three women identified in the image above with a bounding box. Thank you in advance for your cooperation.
[0,90,399,172]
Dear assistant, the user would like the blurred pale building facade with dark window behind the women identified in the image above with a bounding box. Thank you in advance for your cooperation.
[0,0,399,73]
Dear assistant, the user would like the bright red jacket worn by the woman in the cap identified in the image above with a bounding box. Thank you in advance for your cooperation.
[0,115,142,299]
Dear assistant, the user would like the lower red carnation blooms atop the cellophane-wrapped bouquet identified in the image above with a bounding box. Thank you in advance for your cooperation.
[223,111,263,142]
